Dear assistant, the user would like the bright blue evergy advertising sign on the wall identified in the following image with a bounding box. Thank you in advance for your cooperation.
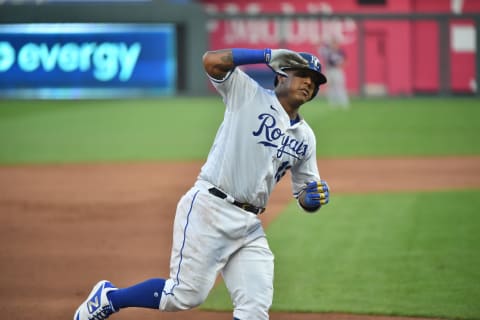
[0,23,176,98]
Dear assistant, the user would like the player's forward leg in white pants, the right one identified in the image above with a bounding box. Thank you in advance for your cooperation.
[222,237,274,320]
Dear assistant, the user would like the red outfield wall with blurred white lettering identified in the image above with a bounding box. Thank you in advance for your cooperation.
[202,0,480,96]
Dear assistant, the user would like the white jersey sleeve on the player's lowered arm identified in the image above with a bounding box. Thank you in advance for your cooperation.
[291,126,320,198]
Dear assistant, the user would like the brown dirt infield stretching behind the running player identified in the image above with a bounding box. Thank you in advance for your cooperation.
[0,157,480,320]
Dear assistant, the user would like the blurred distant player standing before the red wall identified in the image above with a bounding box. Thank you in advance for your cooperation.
[320,37,350,109]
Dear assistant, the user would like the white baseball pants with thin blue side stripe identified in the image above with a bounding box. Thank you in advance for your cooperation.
[159,181,274,320]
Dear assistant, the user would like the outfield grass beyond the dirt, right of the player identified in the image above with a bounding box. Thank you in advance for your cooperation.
[303,98,480,157]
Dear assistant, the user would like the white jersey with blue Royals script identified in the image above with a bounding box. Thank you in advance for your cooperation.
[198,68,320,207]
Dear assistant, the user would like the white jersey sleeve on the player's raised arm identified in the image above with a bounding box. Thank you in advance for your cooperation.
[209,67,260,110]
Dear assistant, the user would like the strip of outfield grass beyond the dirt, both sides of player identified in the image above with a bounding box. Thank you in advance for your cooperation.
[0,96,480,164]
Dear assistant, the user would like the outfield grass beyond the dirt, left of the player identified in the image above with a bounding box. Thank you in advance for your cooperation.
[0,98,223,163]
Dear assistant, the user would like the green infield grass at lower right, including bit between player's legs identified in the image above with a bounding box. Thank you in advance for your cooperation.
[204,190,480,319]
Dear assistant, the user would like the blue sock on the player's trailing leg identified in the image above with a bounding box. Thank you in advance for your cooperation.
[107,278,165,311]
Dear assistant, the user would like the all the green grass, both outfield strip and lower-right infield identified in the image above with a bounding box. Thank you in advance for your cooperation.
[0,97,480,319]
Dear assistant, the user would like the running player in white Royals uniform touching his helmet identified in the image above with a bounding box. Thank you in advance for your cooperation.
[74,49,329,320]
